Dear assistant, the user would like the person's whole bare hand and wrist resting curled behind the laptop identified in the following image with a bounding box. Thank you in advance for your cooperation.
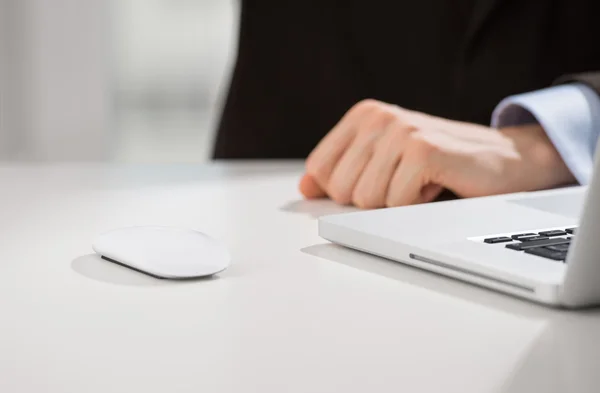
[299,100,575,208]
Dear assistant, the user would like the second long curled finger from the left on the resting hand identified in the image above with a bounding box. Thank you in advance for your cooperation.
[326,114,391,204]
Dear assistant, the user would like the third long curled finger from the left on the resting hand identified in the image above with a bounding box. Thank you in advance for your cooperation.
[352,121,414,209]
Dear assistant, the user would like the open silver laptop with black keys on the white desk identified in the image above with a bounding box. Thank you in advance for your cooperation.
[319,145,600,308]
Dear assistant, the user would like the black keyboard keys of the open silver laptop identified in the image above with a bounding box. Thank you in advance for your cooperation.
[483,228,577,262]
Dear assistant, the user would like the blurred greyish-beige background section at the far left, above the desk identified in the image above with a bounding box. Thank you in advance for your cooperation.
[0,0,114,161]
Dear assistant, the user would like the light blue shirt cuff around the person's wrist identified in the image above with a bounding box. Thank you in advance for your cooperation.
[492,83,600,184]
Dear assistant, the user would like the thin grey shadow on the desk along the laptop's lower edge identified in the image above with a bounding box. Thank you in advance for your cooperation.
[301,243,600,320]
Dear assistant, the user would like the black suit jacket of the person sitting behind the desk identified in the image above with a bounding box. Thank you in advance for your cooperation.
[214,0,600,158]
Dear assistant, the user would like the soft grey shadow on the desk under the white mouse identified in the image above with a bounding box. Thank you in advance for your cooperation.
[71,254,218,287]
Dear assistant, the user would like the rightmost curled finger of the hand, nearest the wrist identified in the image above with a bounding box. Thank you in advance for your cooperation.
[386,132,438,207]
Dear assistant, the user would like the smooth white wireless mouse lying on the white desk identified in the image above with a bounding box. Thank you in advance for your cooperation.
[92,227,231,279]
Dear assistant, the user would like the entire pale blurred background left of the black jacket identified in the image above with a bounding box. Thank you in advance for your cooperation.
[0,0,239,162]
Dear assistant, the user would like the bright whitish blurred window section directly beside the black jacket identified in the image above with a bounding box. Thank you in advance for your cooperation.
[112,0,238,162]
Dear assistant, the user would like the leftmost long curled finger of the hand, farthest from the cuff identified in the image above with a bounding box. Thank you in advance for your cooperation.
[306,100,382,189]
